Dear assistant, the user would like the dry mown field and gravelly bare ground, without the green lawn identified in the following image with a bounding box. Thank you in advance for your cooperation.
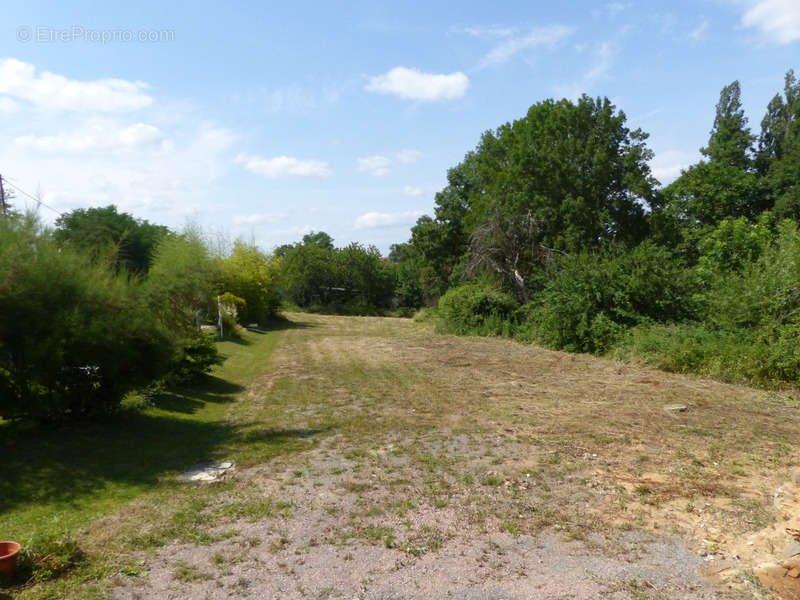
[113,314,800,600]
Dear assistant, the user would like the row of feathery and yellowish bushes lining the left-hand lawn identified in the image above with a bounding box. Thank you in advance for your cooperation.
[0,211,277,420]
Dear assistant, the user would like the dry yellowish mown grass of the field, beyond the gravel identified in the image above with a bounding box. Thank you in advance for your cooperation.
[247,315,800,580]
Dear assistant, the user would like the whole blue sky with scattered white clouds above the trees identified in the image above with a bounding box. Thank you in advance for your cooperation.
[0,0,800,253]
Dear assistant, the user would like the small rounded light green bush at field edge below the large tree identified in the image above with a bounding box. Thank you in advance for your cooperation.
[439,283,519,335]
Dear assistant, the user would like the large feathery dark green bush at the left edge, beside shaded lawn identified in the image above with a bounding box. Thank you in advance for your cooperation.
[0,218,178,420]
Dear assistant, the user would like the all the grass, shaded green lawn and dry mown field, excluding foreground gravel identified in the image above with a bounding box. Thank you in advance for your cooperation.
[6,314,800,596]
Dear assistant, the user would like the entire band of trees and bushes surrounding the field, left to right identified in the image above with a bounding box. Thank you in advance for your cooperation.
[0,71,800,419]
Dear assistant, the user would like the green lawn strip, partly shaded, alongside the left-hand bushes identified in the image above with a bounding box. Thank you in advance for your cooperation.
[0,324,306,597]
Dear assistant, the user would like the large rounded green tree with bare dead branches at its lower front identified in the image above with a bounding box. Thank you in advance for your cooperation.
[400,95,657,300]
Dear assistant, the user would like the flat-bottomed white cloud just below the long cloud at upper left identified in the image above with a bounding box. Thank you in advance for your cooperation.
[14,119,170,153]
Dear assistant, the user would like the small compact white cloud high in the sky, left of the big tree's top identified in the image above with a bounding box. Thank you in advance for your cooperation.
[364,67,469,102]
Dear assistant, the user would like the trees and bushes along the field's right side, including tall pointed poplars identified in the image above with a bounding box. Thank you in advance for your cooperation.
[390,71,800,385]
